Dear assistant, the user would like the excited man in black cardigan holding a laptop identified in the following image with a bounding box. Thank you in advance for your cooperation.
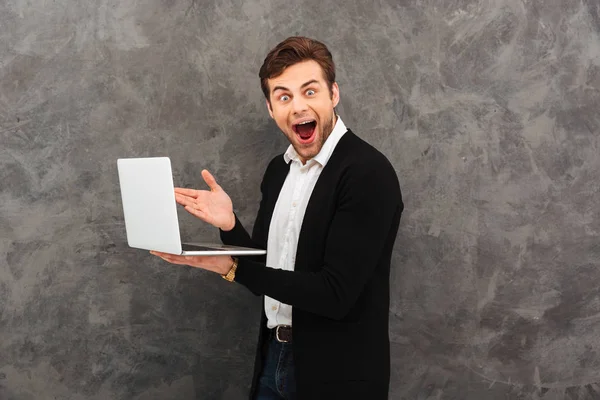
[154,37,403,400]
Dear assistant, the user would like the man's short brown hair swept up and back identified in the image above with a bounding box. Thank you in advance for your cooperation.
[258,36,335,101]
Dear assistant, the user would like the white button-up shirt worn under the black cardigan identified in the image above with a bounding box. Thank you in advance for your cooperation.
[265,116,347,329]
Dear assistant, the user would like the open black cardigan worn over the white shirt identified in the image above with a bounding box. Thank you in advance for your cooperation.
[221,131,404,400]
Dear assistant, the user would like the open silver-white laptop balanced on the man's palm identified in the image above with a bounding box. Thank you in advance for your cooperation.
[117,157,267,256]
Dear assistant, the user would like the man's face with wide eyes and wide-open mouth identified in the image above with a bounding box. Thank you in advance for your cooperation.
[267,60,340,163]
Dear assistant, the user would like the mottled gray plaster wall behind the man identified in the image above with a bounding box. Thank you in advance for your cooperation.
[0,0,600,400]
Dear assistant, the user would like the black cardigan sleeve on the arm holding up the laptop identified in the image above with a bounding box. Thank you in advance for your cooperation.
[235,163,403,319]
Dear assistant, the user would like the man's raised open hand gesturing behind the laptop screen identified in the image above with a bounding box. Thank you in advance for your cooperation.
[175,170,235,231]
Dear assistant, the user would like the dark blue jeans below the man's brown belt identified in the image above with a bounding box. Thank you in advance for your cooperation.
[254,335,296,400]
